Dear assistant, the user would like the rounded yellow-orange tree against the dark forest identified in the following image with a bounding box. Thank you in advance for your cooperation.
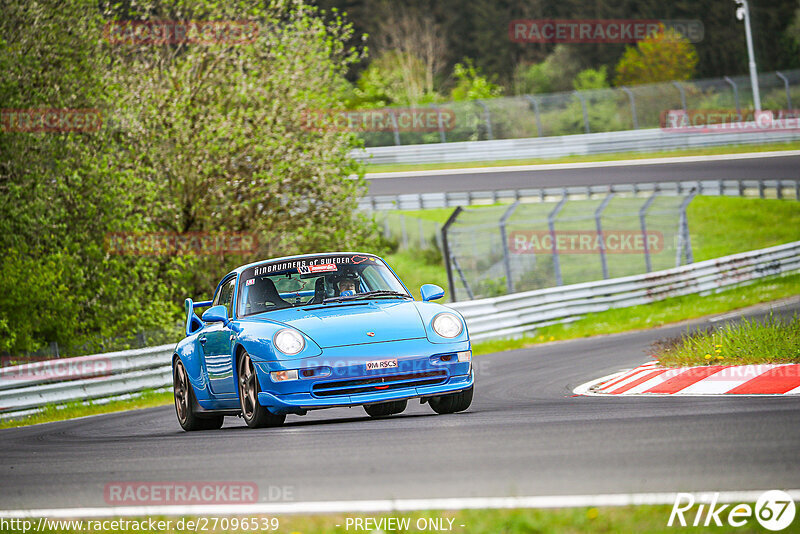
[614,28,698,86]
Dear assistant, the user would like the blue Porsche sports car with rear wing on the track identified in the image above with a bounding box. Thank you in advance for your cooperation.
[172,252,474,430]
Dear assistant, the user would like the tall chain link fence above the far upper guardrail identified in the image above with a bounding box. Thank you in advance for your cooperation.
[359,70,800,147]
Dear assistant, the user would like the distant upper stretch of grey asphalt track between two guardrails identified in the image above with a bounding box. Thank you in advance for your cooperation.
[367,155,800,195]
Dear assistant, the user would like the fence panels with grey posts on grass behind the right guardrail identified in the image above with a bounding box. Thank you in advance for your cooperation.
[442,191,695,301]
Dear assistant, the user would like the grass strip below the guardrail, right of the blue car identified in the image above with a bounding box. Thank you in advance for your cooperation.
[472,274,800,354]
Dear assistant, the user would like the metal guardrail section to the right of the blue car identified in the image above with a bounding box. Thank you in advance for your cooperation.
[448,241,800,341]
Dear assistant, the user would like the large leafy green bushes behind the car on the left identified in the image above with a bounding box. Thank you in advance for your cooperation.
[0,0,388,353]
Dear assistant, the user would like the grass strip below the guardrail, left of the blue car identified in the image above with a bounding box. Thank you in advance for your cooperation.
[0,391,173,429]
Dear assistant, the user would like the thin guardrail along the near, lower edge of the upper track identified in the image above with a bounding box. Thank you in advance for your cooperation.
[358,180,800,211]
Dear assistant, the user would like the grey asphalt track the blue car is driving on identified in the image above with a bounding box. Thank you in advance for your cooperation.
[0,299,800,510]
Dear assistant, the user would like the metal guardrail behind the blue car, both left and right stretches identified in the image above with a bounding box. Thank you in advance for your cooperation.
[0,241,800,418]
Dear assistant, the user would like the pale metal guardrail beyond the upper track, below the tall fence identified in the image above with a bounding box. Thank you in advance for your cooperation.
[350,128,800,165]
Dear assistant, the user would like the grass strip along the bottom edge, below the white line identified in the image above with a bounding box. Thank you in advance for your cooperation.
[33,503,776,534]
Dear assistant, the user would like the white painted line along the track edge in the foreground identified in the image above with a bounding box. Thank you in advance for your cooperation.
[0,489,800,519]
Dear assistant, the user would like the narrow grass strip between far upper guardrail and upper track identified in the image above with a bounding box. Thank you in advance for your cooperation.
[367,141,800,172]
